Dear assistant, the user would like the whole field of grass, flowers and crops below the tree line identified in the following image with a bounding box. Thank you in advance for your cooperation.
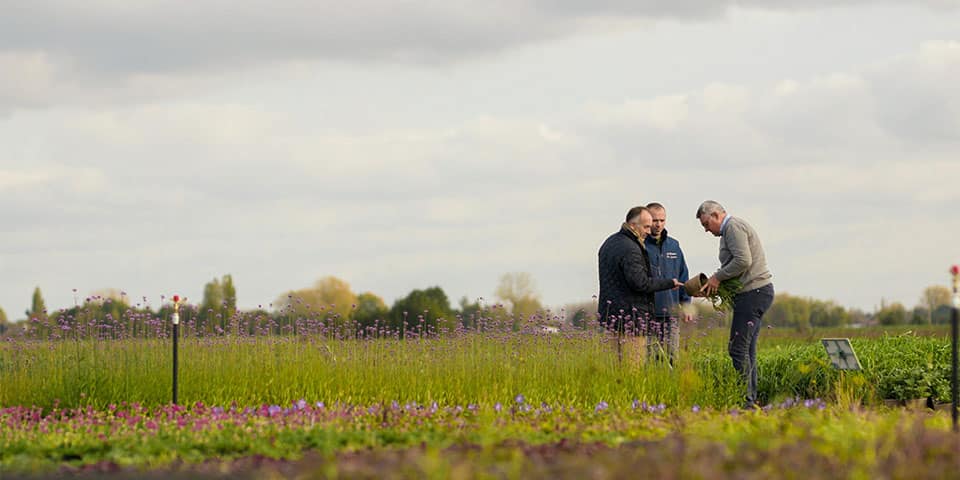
[0,308,960,478]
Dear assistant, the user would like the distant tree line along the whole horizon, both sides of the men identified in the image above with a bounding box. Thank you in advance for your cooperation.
[0,280,951,335]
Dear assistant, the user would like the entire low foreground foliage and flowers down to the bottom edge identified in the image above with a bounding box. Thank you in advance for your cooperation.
[0,399,956,478]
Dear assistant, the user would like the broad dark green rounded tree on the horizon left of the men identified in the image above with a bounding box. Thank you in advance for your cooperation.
[390,287,456,335]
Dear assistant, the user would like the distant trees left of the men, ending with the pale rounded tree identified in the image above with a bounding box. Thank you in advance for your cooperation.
[0,273,543,337]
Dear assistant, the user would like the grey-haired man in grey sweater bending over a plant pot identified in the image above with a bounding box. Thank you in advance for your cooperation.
[697,200,774,408]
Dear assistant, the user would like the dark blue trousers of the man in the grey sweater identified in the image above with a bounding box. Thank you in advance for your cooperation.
[728,285,773,407]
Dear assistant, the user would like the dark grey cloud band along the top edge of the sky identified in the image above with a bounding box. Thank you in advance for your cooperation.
[0,0,956,74]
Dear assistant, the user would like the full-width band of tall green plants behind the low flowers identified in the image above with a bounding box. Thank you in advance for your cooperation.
[0,331,950,408]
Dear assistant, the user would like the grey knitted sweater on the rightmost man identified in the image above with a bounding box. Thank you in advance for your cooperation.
[716,217,773,292]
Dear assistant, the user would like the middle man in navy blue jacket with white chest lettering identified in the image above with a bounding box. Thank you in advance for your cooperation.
[644,202,692,365]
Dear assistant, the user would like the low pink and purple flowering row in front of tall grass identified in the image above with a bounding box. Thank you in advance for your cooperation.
[0,395,955,478]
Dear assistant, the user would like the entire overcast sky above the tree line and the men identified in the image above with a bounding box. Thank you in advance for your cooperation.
[0,0,960,319]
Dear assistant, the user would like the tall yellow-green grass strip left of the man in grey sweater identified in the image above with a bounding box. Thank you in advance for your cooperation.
[0,334,739,407]
